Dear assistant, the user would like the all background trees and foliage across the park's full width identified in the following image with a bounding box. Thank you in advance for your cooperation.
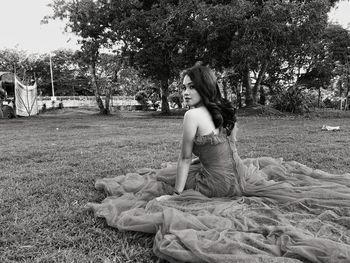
[0,0,350,114]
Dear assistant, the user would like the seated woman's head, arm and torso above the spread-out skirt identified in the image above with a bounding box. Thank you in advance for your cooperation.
[158,66,239,200]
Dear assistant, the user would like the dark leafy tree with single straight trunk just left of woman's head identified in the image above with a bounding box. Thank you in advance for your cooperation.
[112,0,200,114]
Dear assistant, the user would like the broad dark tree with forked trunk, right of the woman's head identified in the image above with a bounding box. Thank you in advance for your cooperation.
[185,0,336,105]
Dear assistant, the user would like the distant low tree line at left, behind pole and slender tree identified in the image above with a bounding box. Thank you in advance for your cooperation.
[0,49,157,106]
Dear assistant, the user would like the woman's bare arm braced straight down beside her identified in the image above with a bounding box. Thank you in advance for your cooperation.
[175,110,198,193]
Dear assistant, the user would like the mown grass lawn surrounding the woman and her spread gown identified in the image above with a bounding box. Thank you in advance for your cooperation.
[0,110,350,263]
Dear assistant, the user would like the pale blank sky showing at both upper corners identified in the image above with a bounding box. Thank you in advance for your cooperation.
[0,0,350,53]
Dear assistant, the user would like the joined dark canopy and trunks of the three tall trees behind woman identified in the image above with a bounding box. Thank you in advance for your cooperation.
[37,0,347,113]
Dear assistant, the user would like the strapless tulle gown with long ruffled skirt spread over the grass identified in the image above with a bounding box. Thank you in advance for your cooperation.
[87,130,350,263]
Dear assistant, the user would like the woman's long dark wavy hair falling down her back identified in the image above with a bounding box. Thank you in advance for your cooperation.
[182,65,237,135]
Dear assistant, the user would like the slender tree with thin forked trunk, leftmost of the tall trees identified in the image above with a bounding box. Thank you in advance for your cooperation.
[43,0,113,114]
